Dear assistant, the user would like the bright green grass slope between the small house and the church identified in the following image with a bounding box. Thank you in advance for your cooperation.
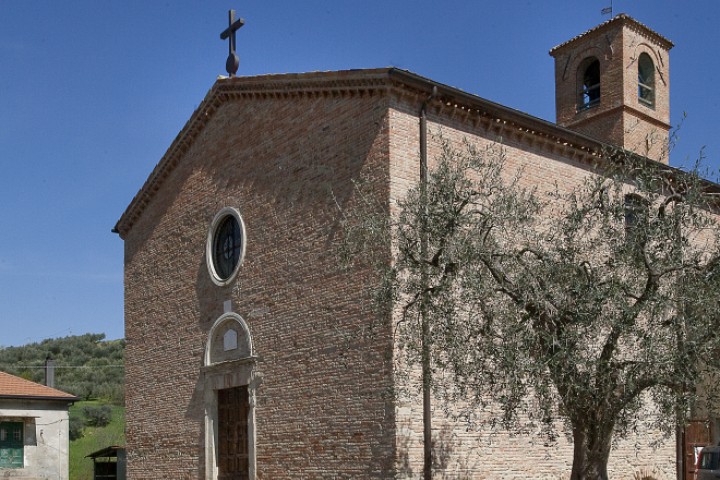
[70,400,125,480]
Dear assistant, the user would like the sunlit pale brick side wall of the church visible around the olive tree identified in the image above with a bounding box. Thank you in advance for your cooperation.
[390,98,675,480]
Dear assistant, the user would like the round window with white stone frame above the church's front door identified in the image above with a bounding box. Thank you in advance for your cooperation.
[206,207,245,285]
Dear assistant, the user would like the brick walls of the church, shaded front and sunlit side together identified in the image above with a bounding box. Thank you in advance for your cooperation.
[121,66,688,480]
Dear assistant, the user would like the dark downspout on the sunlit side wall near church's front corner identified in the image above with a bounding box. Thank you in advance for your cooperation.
[420,86,437,480]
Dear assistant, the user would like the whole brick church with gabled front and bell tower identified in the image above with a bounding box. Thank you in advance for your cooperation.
[115,14,718,480]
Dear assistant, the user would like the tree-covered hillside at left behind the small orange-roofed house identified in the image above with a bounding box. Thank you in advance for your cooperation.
[0,333,125,405]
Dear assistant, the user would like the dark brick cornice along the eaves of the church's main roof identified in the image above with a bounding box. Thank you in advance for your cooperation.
[113,65,708,239]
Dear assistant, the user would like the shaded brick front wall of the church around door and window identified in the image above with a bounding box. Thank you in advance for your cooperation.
[125,92,395,480]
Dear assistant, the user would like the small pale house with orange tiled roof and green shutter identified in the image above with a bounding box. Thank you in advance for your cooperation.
[0,372,78,480]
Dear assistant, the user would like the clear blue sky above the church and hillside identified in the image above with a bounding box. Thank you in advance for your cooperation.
[0,0,720,346]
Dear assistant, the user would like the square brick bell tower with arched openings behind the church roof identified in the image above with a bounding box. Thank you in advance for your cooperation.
[550,14,673,163]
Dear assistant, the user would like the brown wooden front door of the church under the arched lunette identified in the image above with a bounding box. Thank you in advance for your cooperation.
[218,386,249,480]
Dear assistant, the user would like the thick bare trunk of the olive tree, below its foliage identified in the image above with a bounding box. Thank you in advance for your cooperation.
[570,421,613,480]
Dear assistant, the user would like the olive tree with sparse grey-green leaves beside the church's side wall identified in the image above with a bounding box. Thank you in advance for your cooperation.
[344,143,720,480]
